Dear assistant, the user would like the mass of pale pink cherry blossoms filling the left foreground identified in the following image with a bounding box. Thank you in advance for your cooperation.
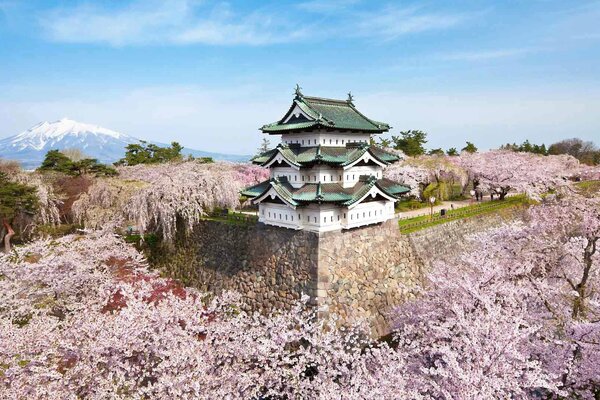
[0,231,421,399]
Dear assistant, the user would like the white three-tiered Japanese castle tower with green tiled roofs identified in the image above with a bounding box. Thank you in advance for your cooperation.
[242,86,410,232]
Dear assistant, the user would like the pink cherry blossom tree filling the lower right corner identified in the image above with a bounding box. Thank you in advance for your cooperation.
[396,196,600,398]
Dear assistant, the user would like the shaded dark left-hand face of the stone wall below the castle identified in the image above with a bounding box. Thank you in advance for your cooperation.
[149,221,318,312]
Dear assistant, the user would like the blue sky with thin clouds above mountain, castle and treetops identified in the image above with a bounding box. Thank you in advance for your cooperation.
[0,0,600,154]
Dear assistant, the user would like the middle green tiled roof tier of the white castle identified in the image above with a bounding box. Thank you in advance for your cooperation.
[252,143,400,167]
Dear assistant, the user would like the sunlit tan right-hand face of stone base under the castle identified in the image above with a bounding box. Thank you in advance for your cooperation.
[317,219,425,336]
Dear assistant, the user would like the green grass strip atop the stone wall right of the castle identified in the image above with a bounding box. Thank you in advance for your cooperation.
[398,195,532,234]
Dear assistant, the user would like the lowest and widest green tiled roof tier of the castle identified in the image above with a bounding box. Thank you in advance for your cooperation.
[242,176,410,206]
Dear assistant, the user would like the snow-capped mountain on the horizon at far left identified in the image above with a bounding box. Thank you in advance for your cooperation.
[0,118,249,168]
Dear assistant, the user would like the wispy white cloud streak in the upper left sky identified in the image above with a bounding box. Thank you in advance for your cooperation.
[40,0,310,46]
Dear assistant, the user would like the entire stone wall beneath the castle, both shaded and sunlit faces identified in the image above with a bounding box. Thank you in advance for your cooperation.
[149,215,514,335]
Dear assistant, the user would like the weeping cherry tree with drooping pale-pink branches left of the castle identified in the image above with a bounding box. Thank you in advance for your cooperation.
[73,161,268,241]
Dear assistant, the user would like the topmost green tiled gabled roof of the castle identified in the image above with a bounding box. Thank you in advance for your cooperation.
[261,91,390,134]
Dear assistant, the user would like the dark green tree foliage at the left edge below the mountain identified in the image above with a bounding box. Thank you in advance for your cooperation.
[0,172,38,220]
